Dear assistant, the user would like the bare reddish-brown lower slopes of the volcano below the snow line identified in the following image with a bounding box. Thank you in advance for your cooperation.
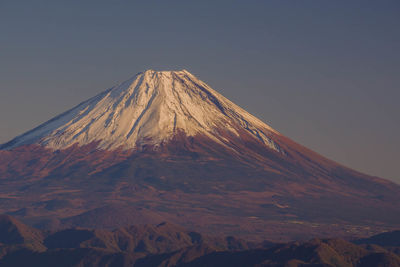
[0,132,400,241]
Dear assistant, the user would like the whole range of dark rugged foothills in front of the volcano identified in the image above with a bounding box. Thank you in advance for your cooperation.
[0,216,400,267]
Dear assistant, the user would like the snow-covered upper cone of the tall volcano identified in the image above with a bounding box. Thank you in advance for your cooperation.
[0,70,280,151]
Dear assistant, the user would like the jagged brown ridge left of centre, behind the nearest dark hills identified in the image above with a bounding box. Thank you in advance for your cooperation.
[44,222,248,254]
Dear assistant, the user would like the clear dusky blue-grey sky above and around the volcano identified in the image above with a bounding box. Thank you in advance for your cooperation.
[0,0,400,183]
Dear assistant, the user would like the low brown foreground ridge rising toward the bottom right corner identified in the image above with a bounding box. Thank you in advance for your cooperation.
[177,239,400,267]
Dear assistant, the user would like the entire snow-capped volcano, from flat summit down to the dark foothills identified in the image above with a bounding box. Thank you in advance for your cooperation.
[0,70,400,241]
